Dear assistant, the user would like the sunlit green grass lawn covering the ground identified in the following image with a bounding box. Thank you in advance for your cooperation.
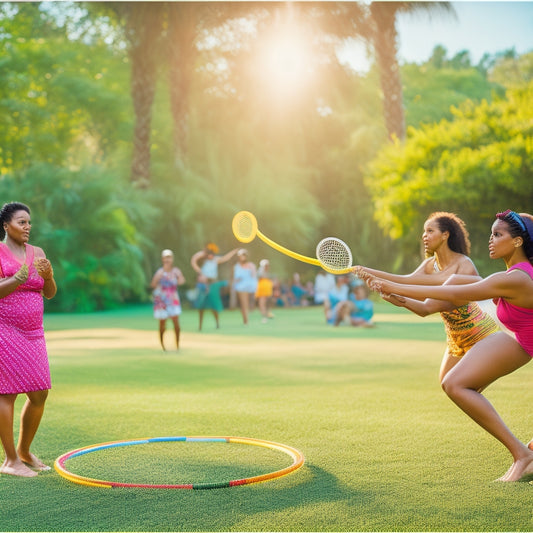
[0,303,533,531]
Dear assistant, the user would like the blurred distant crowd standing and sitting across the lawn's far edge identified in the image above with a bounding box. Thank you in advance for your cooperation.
[151,243,374,349]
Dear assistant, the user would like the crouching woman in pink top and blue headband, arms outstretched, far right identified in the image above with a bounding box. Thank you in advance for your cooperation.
[369,210,533,481]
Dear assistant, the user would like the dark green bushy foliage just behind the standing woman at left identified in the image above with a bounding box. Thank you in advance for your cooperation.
[0,163,154,311]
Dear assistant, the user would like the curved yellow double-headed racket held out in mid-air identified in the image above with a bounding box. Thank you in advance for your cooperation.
[231,211,352,274]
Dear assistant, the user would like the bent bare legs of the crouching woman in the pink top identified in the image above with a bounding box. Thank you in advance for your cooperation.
[442,332,533,481]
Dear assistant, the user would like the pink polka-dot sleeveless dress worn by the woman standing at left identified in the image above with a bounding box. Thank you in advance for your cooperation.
[0,243,51,394]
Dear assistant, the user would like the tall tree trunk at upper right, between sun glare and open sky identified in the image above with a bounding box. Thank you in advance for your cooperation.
[370,2,455,140]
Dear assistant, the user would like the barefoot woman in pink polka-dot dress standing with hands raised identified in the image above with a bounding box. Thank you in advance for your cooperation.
[0,202,57,477]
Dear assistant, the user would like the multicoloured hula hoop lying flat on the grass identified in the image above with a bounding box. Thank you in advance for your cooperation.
[54,437,305,489]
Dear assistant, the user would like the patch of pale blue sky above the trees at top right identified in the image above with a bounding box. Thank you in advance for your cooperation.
[397,1,533,63]
